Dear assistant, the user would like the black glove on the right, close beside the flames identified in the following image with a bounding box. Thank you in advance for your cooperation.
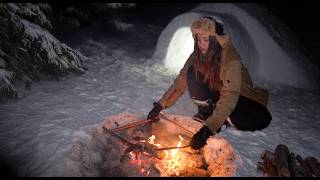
[190,126,213,149]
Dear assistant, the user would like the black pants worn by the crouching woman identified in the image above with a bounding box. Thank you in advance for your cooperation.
[187,66,272,131]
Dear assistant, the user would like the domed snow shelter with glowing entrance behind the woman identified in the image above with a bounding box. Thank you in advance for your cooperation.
[153,3,319,89]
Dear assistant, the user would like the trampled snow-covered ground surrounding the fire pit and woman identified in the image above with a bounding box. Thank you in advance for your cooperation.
[0,2,320,176]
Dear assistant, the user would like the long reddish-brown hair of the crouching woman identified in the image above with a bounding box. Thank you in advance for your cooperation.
[194,18,223,89]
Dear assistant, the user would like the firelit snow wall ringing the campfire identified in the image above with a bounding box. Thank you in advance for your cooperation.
[63,113,237,177]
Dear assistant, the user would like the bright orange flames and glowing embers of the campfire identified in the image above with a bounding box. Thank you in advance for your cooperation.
[123,135,209,177]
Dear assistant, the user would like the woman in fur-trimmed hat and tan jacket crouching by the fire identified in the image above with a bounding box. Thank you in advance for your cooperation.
[148,17,272,149]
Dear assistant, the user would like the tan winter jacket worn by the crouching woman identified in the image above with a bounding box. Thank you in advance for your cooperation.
[159,36,269,132]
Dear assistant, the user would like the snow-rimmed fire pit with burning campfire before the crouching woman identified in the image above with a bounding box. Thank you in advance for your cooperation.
[64,113,237,177]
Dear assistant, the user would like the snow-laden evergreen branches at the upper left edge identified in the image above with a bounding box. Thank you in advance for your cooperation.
[0,3,87,97]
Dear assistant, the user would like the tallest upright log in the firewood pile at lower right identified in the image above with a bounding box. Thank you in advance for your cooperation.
[274,144,290,177]
